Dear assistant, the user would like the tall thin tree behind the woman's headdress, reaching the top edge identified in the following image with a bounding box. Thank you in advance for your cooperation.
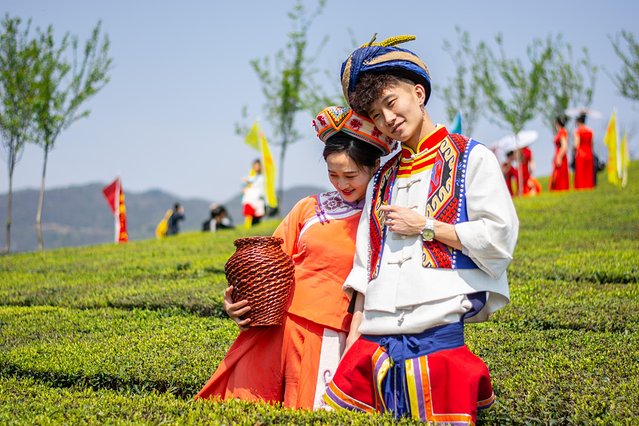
[236,0,335,210]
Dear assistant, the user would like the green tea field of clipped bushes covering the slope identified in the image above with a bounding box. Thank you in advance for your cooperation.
[0,161,639,425]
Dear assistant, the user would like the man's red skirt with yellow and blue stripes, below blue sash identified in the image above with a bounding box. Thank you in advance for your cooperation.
[324,338,495,425]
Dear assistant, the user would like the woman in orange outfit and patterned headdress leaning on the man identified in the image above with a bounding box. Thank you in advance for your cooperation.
[196,107,394,409]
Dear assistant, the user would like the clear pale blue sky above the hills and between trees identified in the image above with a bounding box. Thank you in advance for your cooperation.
[0,0,639,201]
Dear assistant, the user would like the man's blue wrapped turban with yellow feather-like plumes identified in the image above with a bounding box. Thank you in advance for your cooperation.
[341,34,430,104]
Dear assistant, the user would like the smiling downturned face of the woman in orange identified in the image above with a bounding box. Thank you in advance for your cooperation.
[326,152,373,203]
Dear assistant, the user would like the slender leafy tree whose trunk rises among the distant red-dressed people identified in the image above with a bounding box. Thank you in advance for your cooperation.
[477,34,553,194]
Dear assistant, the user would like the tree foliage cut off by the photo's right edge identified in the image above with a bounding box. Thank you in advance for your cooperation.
[610,31,639,101]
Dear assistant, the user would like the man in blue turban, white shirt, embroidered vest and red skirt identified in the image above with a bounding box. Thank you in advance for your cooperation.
[324,36,519,424]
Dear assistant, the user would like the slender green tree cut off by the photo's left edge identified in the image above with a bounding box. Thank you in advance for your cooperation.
[0,15,38,253]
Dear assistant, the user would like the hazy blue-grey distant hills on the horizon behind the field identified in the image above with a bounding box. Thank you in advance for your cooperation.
[0,183,322,252]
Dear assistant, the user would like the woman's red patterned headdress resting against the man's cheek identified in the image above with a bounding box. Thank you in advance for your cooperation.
[313,106,395,155]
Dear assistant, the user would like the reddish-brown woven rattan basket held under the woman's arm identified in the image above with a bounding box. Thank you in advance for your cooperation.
[224,237,295,327]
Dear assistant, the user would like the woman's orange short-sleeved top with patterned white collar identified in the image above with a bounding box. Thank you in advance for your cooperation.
[273,191,364,332]
